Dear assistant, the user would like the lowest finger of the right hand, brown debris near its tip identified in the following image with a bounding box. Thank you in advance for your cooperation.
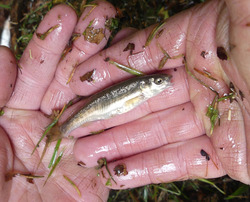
[100,136,225,189]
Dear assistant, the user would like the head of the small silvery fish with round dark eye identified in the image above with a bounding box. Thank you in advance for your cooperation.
[140,74,172,98]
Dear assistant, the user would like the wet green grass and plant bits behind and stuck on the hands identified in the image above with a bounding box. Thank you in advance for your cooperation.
[0,0,250,202]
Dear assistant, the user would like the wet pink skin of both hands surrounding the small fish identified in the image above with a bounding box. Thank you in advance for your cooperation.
[0,0,250,201]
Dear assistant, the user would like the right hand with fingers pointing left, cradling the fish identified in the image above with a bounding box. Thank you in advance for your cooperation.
[70,0,250,189]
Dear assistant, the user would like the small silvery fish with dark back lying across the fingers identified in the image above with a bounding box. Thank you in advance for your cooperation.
[47,74,172,142]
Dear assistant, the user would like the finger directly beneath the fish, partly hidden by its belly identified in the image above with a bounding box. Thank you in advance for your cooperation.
[60,67,189,137]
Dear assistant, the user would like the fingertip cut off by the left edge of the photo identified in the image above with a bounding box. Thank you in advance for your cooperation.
[0,46,17,109]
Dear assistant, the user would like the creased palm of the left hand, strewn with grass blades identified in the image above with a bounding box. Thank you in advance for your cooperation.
[1,109,108,201]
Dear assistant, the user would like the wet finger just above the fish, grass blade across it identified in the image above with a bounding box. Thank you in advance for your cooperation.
[70,8,188,95]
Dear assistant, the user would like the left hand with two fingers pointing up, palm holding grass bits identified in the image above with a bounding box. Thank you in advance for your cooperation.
[0,2,115,201]
